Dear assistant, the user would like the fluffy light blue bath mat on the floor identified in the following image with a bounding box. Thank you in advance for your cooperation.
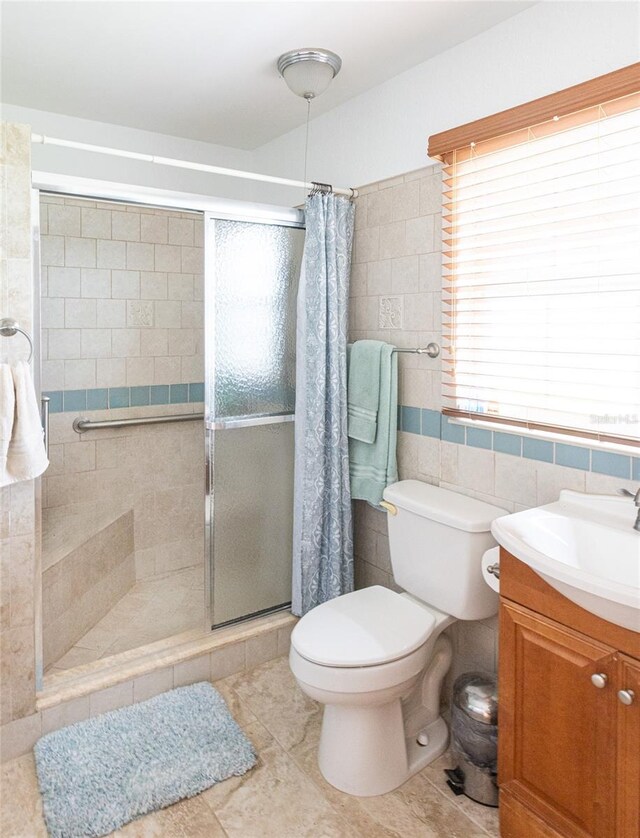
[34,682,256,838]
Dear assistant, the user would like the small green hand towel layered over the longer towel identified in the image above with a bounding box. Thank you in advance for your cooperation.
[347,340,386,442]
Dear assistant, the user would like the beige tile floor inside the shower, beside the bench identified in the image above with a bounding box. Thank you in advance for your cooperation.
[45,566,204,675]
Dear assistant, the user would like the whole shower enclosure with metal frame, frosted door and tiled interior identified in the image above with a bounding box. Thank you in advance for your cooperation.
[35,182,304,675]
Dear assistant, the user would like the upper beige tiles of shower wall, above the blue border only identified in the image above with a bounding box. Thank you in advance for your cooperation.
[40,195,203,391]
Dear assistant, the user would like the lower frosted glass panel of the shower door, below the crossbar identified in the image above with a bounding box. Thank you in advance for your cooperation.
[209,422,294,625]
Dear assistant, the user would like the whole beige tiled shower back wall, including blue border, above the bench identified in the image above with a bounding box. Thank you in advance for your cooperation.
[41,195,204,579]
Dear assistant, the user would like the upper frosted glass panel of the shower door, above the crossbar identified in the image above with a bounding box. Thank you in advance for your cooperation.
[209,220,304,418]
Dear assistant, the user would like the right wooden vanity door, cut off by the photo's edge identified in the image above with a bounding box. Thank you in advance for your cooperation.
[616,656,640,838]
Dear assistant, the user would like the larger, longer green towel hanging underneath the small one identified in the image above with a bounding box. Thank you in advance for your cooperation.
[349,344,398,506]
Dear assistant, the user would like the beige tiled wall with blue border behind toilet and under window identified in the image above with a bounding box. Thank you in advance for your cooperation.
[350,166,640,678]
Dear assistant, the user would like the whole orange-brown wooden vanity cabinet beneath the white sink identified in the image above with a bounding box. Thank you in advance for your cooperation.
[498,549,640,838]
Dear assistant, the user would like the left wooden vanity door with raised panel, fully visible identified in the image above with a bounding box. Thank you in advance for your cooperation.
[498,603,617,838]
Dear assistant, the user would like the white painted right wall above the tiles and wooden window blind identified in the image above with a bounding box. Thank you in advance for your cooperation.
[255,0,640,202]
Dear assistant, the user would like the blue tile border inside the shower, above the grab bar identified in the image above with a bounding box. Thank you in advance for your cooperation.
[42,381,205,416]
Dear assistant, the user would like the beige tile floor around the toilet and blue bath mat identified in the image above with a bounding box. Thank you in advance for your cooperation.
[0,658,499,838]
